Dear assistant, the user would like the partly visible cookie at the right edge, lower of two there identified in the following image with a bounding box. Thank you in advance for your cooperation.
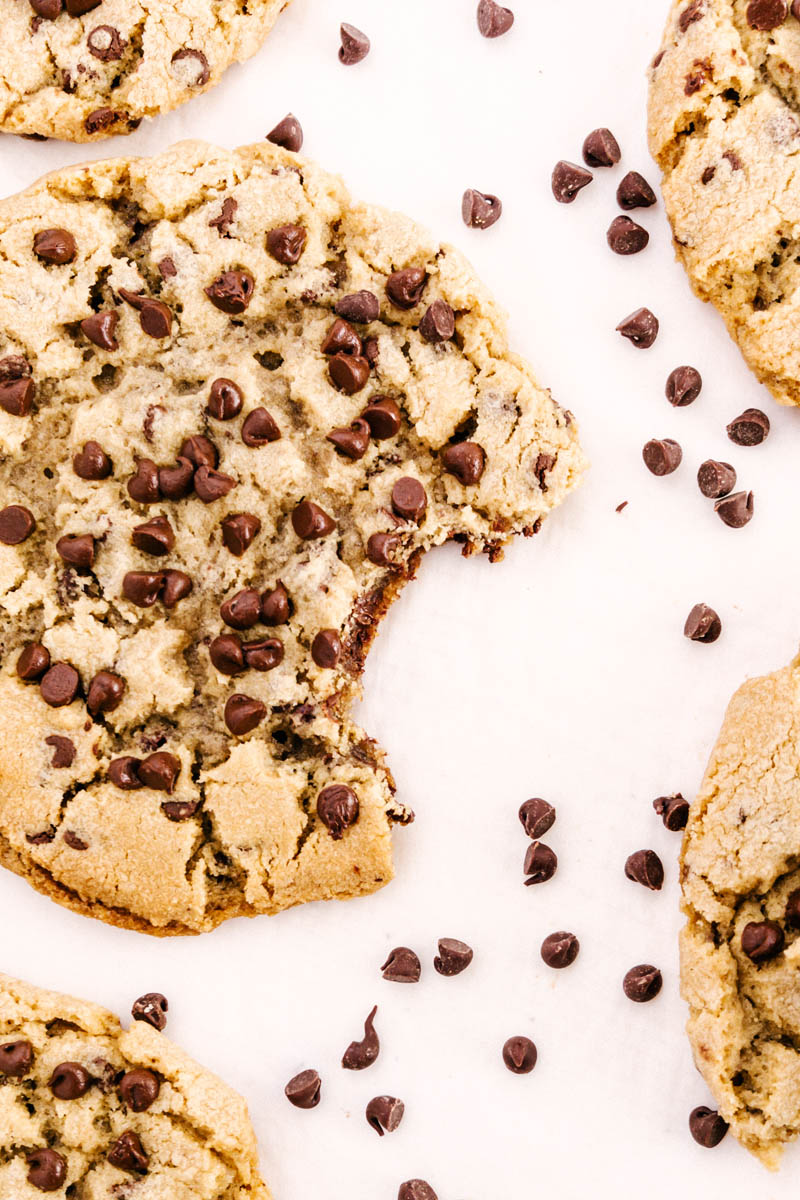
[681,658,800,1166]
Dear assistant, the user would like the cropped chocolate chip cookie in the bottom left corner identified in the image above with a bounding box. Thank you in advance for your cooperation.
[0,974,270,1200]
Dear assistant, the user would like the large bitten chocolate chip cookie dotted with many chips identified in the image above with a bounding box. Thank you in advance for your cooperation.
[0,136,583,934]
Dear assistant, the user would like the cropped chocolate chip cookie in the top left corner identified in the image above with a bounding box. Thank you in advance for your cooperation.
[0,0,289,142]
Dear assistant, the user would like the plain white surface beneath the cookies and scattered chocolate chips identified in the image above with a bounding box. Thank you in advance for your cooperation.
[0,0,800,1200]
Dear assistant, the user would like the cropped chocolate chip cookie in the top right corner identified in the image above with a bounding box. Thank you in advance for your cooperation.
[649,0,800,404]
